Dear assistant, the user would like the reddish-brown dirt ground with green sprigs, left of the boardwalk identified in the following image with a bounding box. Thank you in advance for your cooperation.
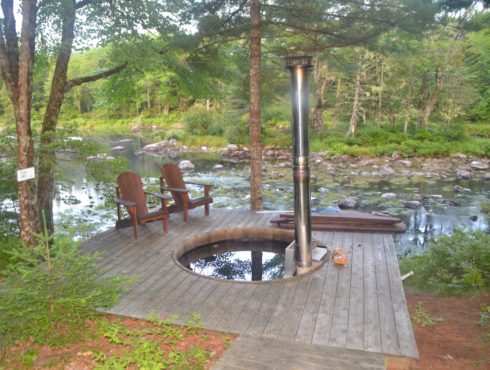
[0,316,236,370]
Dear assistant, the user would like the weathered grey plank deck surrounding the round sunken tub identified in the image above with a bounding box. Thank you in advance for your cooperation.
[82,209,418,358]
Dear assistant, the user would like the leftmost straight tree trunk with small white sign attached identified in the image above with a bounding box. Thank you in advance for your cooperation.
[16,0,39,246]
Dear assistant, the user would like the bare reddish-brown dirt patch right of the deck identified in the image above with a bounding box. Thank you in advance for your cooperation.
[406,291,490,370]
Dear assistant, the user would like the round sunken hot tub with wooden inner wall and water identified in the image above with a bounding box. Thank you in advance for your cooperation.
[173,228,294,282]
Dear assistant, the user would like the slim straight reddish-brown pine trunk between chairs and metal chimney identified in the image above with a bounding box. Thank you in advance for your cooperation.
[250,0,263,211]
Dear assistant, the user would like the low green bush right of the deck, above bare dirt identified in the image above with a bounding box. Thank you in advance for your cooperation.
[401,231,490,294]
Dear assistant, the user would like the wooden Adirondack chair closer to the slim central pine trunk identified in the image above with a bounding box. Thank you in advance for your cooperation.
[160,164,213,222]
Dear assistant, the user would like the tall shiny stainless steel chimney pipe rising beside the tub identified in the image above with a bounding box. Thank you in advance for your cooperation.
[286,56,312,269]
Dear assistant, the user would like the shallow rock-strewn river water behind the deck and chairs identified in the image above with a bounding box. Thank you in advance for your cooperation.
[54,137,490,256]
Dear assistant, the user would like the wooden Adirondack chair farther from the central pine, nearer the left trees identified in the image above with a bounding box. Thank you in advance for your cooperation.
[116,172,172,239]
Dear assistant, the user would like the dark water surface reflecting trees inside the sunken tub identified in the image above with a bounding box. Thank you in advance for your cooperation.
[179,240,288,281]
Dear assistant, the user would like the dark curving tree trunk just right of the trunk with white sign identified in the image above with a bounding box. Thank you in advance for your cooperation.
[38,0,76,234]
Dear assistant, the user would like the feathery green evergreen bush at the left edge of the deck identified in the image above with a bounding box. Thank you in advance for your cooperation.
[0,230,130,345]
